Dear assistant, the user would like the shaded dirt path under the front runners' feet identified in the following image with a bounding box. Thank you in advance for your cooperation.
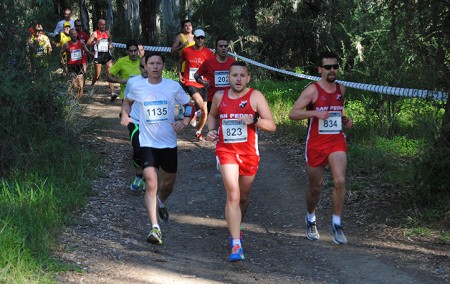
[54,88,449,283]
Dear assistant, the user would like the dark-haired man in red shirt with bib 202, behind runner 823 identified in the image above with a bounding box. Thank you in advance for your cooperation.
[194,38,236,112]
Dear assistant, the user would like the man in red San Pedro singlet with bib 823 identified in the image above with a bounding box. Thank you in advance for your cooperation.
[207,61,276,261]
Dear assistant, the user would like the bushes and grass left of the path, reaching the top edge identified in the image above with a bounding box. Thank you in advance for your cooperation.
[0,0,99,283]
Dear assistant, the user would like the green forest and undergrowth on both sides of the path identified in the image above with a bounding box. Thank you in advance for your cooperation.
[0,0,450,282]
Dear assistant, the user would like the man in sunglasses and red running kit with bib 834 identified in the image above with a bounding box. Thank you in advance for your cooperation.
[289,52,353,244]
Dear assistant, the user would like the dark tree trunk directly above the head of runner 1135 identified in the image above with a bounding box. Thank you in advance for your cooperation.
[140,0,157,45]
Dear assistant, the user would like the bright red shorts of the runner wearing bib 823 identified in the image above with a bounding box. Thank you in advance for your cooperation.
[216,152,259,176]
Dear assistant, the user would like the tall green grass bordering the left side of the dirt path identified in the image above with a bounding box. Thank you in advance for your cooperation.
[0,102,98,283]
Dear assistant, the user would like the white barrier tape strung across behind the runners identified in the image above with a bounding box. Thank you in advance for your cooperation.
[113,43,448,102]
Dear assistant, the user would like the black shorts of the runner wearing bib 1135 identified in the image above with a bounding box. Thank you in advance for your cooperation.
[141,147,178,174]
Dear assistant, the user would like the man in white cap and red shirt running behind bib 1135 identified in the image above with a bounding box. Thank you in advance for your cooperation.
[178,29,214,141]
